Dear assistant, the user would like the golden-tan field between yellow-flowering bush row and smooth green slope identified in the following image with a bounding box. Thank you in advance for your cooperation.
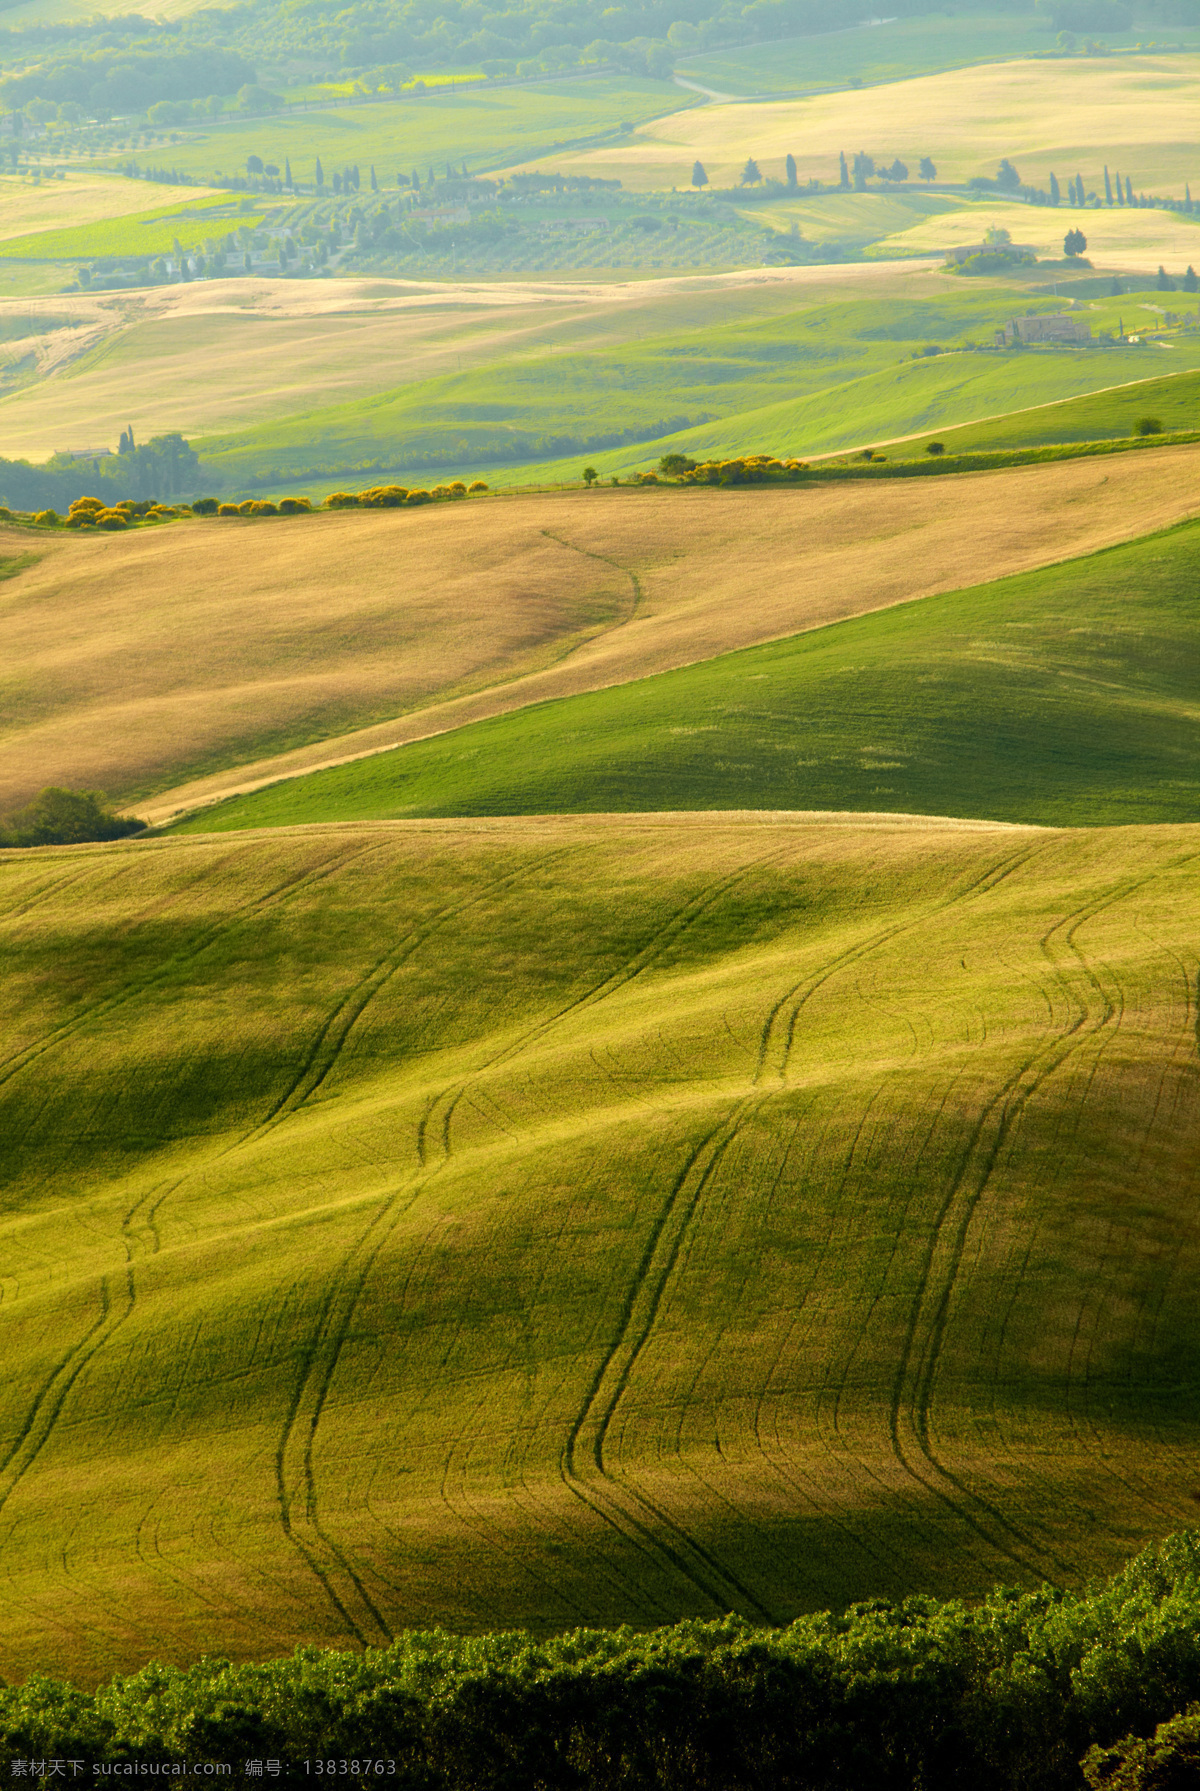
[0,448,1200,818]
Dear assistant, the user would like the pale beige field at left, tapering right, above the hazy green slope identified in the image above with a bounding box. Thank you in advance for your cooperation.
[0,261,947,460]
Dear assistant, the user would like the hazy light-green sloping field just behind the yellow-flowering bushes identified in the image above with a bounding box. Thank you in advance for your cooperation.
[197,285,1200,489]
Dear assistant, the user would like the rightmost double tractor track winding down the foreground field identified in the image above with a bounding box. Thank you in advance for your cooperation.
[888,853,1196,1576]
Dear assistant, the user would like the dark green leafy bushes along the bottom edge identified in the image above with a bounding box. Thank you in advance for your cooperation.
[0,1531,1200,1791]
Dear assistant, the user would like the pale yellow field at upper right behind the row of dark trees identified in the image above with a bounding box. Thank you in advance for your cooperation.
[515,54,1200,197]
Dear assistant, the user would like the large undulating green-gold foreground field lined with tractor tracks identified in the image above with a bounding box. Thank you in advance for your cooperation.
[0,815,1200,1673]
